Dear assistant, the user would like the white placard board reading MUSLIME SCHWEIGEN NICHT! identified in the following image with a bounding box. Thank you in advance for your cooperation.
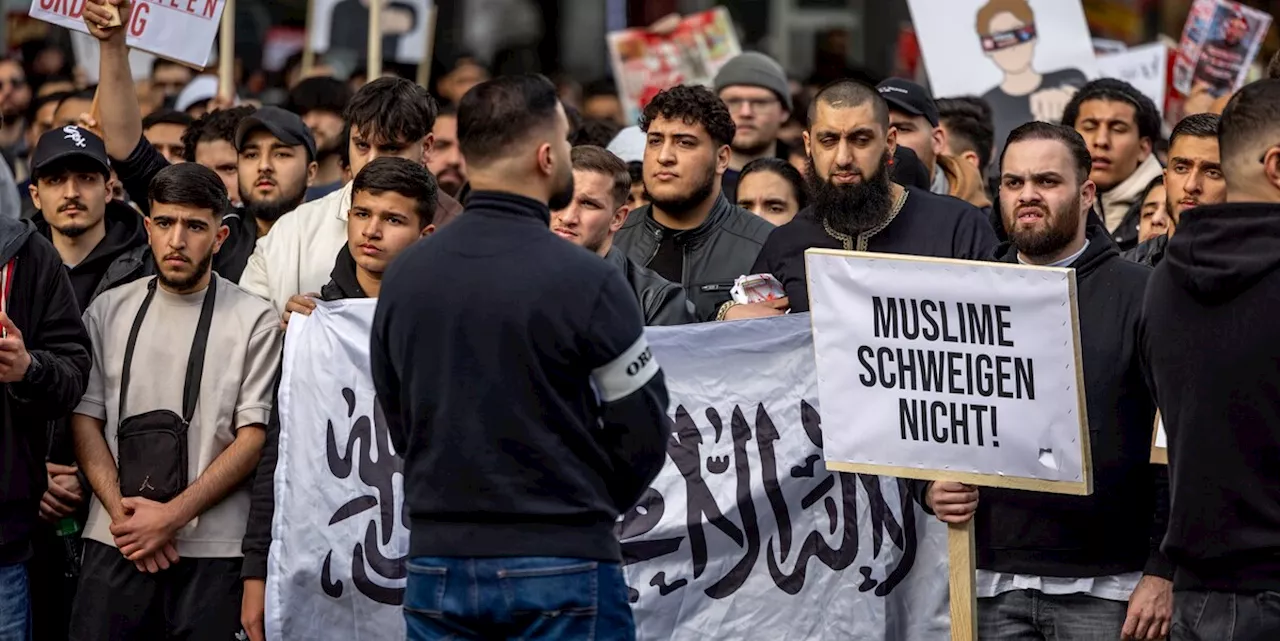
[805,249,1089,493]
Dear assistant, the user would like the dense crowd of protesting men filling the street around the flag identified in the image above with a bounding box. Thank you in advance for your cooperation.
[0,0,1280,641]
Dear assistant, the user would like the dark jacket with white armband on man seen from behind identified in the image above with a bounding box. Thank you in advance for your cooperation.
[370,191,671,562]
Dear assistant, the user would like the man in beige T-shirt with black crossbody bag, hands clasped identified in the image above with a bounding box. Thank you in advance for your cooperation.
[70,162,282,641]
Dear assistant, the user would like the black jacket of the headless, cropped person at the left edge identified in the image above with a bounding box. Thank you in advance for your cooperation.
[0,219,92,564]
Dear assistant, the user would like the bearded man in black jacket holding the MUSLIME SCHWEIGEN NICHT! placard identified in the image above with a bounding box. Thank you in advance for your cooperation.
[920,123,1172,641]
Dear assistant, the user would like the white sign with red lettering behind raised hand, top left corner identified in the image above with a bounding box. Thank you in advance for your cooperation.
[31,0,227,68]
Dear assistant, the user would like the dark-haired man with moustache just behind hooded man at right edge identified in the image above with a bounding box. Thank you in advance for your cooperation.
[1123,114,1226,267]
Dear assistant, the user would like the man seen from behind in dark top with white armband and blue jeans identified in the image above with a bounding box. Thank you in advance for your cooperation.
[370,75,671,641]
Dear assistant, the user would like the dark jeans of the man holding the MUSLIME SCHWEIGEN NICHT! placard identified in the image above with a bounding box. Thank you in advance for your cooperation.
[978,590,1129,641]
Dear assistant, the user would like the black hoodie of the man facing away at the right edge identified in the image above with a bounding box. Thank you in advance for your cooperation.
[1142,203,1280,592]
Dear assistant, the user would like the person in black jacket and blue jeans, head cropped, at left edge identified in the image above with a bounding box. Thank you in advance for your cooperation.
[0,218,91,638]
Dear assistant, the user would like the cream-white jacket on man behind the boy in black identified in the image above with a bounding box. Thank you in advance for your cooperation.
[239,182,351,313]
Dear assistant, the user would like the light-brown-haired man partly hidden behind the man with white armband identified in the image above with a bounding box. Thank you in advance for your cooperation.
[552,145,694,325]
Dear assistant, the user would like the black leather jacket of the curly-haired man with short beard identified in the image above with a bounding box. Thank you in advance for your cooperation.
[613,190,773,320]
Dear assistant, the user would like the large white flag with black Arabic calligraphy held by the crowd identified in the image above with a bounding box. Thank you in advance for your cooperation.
[266,301,950,641]
